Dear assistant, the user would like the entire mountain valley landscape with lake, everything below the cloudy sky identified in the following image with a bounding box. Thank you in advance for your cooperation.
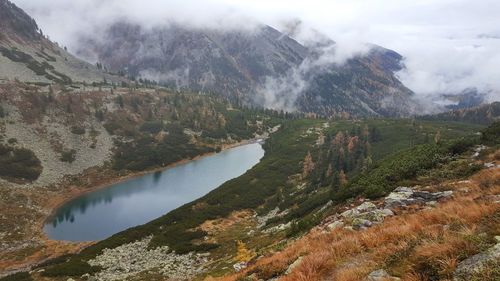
[0,0,500,281]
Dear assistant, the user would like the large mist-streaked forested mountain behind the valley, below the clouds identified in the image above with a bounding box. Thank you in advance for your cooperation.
[77,21,417,117]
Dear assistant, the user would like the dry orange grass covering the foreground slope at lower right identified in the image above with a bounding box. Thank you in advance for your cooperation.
[215,166,500,281]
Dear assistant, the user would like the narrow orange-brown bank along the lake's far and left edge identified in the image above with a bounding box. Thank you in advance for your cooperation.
[38,134,268,240]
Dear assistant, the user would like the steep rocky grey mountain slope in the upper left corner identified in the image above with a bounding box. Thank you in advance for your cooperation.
[0,0,122,84]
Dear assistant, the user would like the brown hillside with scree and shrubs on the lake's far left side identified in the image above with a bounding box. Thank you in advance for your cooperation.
[0,78,286,271]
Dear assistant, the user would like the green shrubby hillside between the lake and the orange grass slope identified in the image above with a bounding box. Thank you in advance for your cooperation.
[9,116,484,280]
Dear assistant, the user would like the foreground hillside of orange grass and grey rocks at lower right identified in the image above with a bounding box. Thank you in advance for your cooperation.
[218,126,500,281]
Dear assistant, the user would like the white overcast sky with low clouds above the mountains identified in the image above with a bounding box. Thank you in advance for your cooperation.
[13,0,500,101]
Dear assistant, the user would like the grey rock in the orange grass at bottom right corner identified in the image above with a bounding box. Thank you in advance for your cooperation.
[453,236,500,281]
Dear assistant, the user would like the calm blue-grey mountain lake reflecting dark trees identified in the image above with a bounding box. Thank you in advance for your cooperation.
[44,143,264,241]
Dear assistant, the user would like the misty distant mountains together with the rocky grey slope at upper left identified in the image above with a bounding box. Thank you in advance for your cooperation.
[0,0,419,118]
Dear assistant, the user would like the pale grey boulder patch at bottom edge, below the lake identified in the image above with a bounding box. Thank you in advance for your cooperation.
[88,237,208,280]
